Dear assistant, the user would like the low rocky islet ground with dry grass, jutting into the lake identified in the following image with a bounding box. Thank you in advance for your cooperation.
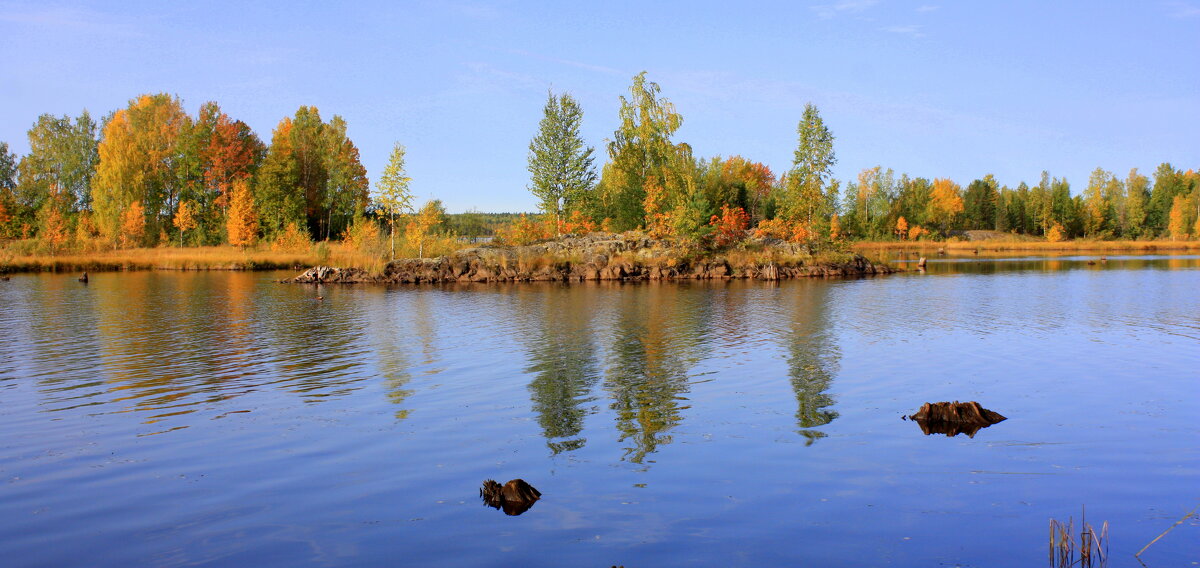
[282,233,898,283]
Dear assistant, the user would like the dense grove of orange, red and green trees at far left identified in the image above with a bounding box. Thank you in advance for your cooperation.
[0,94,370,250]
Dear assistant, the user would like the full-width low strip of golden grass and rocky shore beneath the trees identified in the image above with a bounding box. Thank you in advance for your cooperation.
[0,232,1200,274]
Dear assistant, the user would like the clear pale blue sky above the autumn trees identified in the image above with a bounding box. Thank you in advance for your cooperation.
[0,0,1200,213]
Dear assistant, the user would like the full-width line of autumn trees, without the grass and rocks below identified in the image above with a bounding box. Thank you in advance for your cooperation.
[0,72,1200,253]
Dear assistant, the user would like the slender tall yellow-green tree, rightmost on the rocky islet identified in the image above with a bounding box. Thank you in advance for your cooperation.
[779,103,838,234]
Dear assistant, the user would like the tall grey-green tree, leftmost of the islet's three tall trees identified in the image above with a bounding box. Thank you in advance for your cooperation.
[528,92,596,227]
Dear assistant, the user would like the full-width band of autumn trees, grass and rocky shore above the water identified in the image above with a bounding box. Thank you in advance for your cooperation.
[0,71,1200,281]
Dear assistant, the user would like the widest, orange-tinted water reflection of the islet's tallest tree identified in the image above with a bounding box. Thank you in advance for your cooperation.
[606,285,708,464]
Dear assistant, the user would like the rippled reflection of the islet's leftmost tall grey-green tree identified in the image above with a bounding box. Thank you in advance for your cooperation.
[517,286,599,454]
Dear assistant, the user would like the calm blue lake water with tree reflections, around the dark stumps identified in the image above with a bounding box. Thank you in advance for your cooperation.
[0,256,1200,561]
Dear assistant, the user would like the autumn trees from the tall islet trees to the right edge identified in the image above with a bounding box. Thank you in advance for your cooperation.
[529,72,1200,244]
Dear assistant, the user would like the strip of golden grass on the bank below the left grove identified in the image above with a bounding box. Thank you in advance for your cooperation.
[0,243,384,273]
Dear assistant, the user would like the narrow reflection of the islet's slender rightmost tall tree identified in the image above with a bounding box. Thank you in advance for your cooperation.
[787,281,841,446]
